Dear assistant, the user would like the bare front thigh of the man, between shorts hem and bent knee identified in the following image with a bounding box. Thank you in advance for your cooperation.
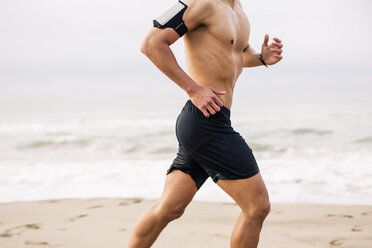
[217,173,269,211]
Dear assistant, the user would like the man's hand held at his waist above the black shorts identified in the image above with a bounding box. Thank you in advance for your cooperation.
[189,86,226,117]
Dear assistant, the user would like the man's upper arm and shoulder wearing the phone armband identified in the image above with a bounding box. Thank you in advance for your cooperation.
[148,0,212,45]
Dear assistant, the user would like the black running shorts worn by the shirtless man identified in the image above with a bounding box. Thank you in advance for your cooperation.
[167,100,259,189]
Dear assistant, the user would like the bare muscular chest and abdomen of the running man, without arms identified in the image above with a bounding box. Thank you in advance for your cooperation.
[184,0,250,109]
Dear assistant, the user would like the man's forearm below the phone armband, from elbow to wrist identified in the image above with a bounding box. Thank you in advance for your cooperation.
[143,41,198,95]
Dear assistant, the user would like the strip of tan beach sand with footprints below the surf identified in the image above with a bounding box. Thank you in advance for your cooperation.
[0,198,372,248]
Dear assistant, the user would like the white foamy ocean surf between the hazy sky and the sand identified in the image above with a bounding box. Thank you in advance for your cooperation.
[0,98,372,204]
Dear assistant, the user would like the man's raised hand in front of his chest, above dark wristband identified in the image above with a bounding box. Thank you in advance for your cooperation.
[261,34,283,65]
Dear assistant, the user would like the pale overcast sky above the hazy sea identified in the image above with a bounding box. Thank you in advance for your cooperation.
[0,0,372,110]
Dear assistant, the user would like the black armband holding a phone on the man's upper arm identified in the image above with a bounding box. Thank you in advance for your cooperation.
[153,1,188,37]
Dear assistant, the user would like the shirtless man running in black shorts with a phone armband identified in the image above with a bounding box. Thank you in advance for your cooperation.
[128,0,283,248]
